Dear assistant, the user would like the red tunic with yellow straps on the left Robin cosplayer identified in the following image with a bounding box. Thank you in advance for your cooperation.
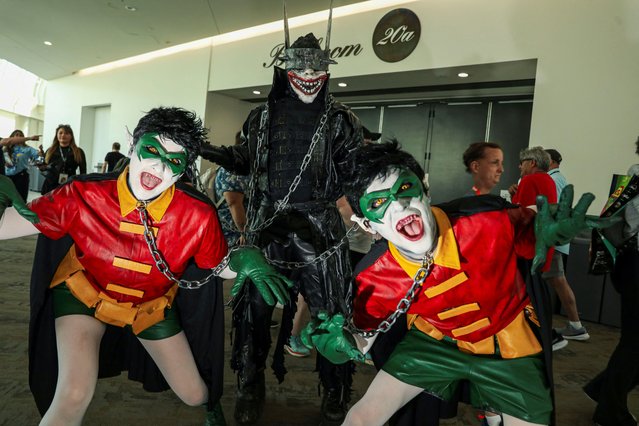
[29,171,227,305]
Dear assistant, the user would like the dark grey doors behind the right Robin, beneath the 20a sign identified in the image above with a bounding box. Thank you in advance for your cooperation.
[353,98,532,204]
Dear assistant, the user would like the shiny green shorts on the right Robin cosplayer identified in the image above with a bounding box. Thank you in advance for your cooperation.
[383,328,553,425]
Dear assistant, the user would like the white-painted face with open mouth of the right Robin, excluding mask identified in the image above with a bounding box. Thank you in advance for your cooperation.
[352,171,437,261]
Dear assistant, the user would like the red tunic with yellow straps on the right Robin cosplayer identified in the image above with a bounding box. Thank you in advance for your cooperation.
[354,208,535,343]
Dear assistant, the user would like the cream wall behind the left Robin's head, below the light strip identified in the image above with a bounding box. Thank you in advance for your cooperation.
[43,49,210,171]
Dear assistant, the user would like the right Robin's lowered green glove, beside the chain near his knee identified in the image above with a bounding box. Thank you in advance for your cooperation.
[300,312,365,364]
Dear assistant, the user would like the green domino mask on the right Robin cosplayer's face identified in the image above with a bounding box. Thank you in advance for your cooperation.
[359,169,424,223]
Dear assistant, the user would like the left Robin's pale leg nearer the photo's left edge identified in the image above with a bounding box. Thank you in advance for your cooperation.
[40,315,106,426]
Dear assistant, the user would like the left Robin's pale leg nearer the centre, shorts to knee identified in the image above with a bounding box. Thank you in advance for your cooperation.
[139,331,209,406]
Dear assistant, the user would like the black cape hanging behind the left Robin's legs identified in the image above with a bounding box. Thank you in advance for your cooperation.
[29,234,224,415]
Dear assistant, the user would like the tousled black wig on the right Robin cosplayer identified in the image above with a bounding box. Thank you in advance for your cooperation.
[342,139,426,216]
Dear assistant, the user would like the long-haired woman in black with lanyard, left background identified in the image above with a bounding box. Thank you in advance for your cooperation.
[42,124,87,194]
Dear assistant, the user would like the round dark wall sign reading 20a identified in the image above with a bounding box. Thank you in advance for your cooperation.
[373,9,421,62]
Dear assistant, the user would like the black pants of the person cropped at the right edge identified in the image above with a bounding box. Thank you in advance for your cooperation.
[585,246,639,426]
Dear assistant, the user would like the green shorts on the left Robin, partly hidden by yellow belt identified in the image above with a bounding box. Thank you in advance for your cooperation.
[52,283,182,340]
